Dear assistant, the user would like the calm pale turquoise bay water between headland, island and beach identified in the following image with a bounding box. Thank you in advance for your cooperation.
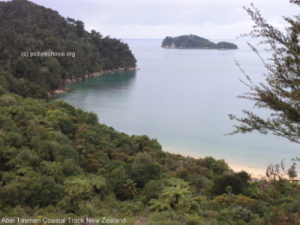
[58,40,299,168]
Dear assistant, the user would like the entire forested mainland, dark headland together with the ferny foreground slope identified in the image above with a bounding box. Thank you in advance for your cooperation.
[0,0,300,225]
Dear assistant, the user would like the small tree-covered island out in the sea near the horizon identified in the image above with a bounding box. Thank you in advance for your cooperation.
[161,34,238,49]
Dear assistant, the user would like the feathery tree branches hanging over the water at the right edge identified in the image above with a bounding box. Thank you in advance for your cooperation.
[229,1,300,143]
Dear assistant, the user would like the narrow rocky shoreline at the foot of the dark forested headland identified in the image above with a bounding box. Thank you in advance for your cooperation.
[48,67,139,98]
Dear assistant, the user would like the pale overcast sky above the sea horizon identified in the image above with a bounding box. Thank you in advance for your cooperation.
[9,0,300,39]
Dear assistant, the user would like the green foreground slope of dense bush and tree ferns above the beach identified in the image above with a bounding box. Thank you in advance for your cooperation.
[0,87,300,225]
